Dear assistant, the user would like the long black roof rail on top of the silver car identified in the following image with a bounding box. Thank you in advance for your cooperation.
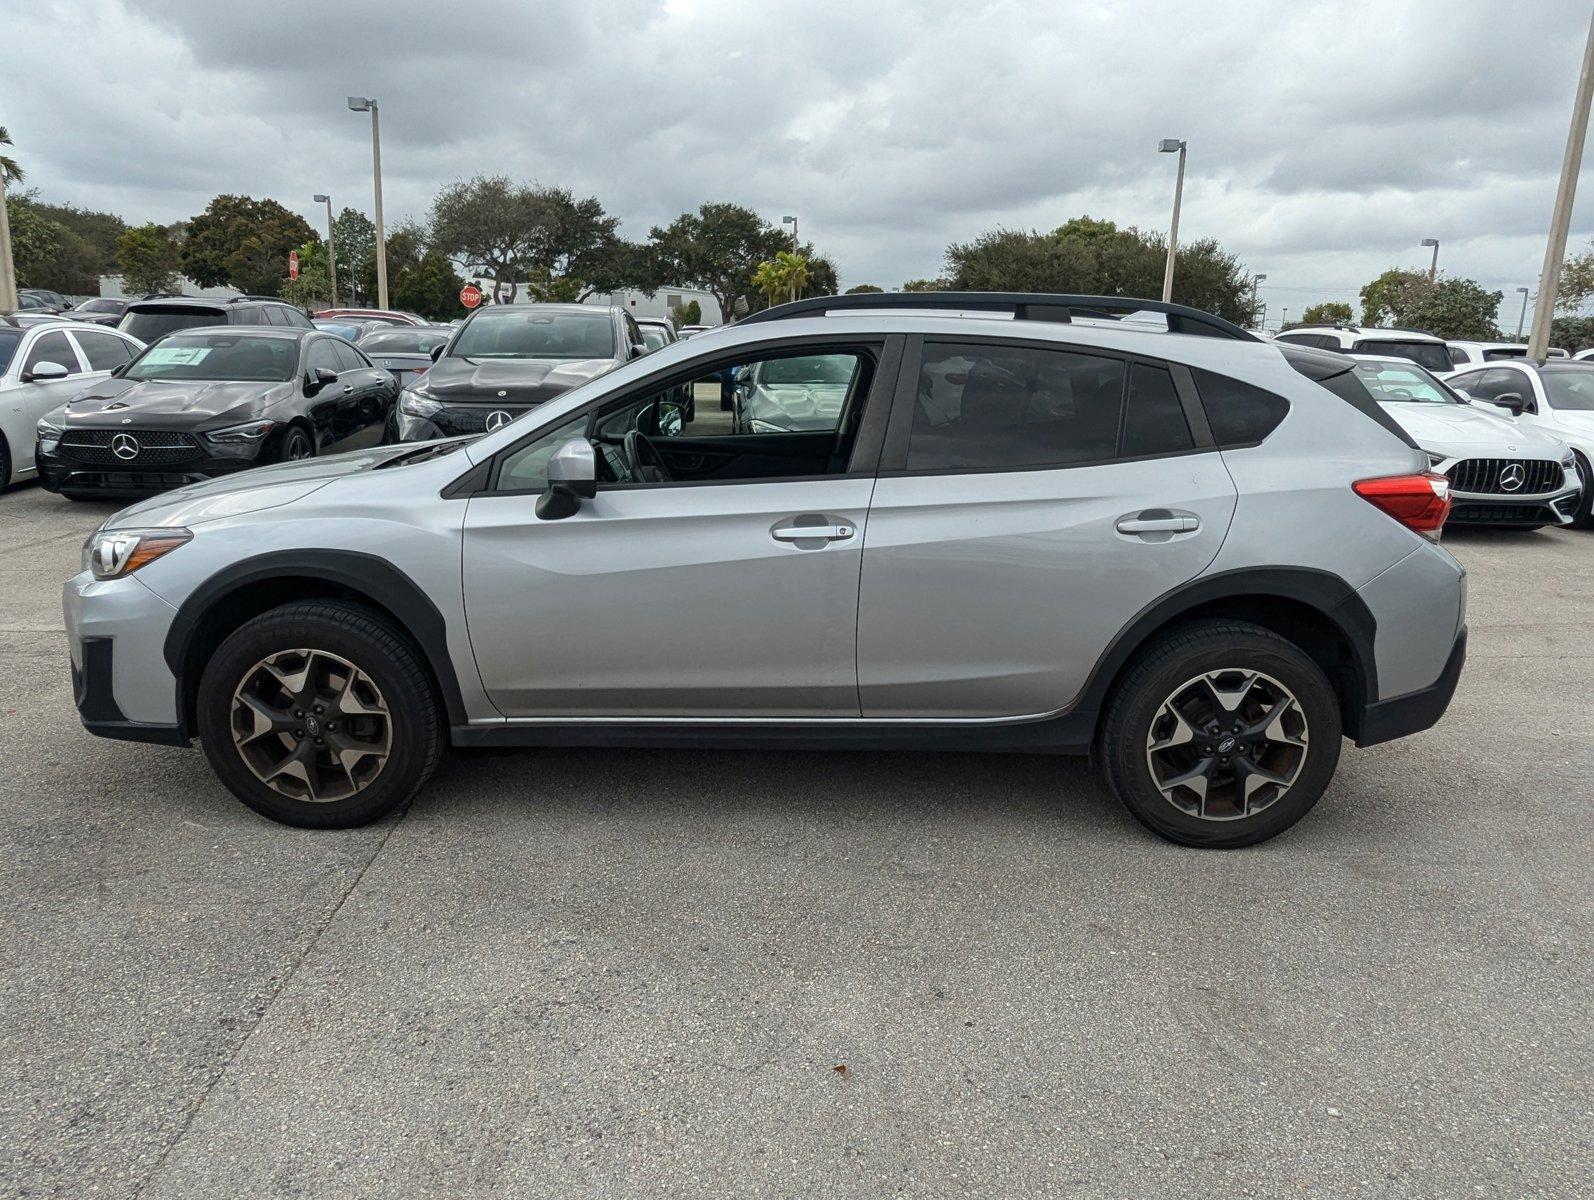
[736,292,1261,341]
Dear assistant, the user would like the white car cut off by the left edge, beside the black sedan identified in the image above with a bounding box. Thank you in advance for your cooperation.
[0,317,143,488]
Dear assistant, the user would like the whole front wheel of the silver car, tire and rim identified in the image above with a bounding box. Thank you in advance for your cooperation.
[198,601,443,829]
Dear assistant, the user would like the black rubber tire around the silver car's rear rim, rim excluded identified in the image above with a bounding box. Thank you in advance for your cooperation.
[1100,620,1342,849]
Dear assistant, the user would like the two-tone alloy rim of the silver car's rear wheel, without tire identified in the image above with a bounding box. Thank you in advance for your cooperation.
[1146,668,1307,821]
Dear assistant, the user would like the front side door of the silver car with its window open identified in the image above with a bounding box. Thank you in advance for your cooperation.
[464,339,883,720]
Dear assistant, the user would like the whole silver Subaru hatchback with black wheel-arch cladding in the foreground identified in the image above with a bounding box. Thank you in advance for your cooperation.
[65,293,1466,846]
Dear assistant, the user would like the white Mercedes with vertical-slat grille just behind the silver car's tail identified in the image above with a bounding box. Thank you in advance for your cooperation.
[1355,357,1594,529]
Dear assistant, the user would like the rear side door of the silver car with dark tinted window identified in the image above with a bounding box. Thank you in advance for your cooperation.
[858,339,1235,719]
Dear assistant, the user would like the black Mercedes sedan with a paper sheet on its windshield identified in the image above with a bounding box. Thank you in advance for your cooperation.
[38,325,399,499]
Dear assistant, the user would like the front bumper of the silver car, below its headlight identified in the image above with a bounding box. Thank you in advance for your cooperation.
[61,572,188,746]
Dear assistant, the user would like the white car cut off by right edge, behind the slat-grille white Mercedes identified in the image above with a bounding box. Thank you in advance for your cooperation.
[1446,359,1594,529]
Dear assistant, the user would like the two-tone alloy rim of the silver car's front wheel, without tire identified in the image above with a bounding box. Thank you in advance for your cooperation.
[230,649,392,803]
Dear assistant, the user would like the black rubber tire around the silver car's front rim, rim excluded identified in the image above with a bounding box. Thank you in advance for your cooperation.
[196,601,445,829]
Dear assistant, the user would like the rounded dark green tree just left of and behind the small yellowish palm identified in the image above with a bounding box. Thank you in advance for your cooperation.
[649,202,791,320]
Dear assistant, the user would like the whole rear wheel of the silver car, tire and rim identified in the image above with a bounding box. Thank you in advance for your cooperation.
[1101,620,1341,848]
